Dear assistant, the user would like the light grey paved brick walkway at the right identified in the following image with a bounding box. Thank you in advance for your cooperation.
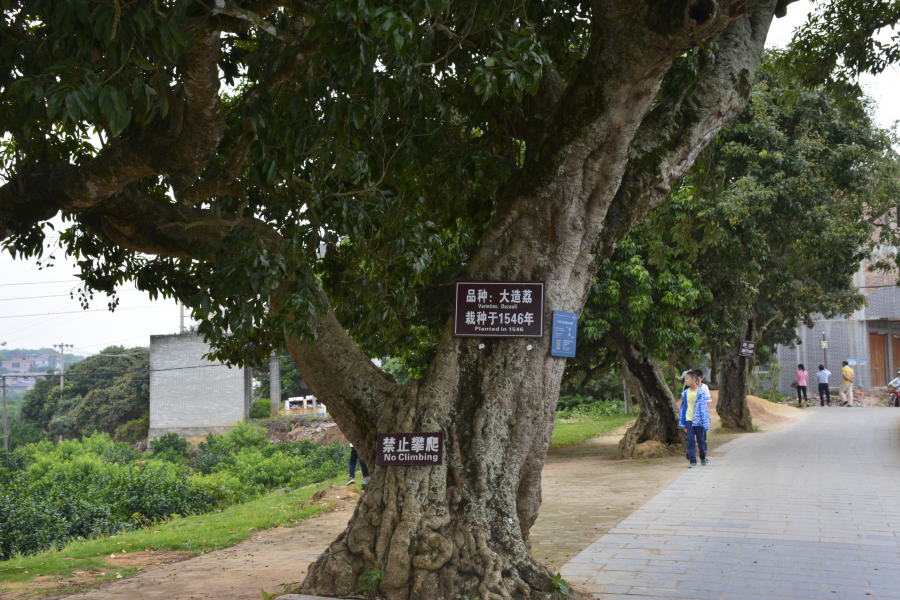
[561,408,900,600]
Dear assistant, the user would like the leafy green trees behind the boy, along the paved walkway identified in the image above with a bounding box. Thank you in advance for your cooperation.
[567,57,900,456]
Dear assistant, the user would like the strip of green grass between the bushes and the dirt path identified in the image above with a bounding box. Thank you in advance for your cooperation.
[0,477,346,594]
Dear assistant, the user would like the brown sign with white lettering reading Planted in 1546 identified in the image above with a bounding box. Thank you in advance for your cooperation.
[453,281,544,337]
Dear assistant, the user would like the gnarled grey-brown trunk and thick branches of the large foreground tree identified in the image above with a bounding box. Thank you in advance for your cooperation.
[0,0,784,600]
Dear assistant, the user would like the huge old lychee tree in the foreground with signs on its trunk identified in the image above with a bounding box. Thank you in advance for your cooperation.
[0,0,788,600]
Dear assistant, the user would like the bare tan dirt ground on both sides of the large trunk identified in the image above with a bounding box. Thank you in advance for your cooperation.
[61,401,803,600]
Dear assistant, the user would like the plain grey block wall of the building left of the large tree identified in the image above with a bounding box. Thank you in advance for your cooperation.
[150,335,253,439]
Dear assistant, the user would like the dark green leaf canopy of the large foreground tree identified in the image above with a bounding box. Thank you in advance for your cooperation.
[0,0,591,368]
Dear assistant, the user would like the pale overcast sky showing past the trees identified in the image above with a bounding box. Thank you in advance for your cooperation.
[0,1,900,354]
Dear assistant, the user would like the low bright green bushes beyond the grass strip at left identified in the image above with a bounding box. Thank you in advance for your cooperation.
[0,423,350,560]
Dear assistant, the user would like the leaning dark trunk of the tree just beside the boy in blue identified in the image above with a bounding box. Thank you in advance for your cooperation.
[609,329,685,458]
